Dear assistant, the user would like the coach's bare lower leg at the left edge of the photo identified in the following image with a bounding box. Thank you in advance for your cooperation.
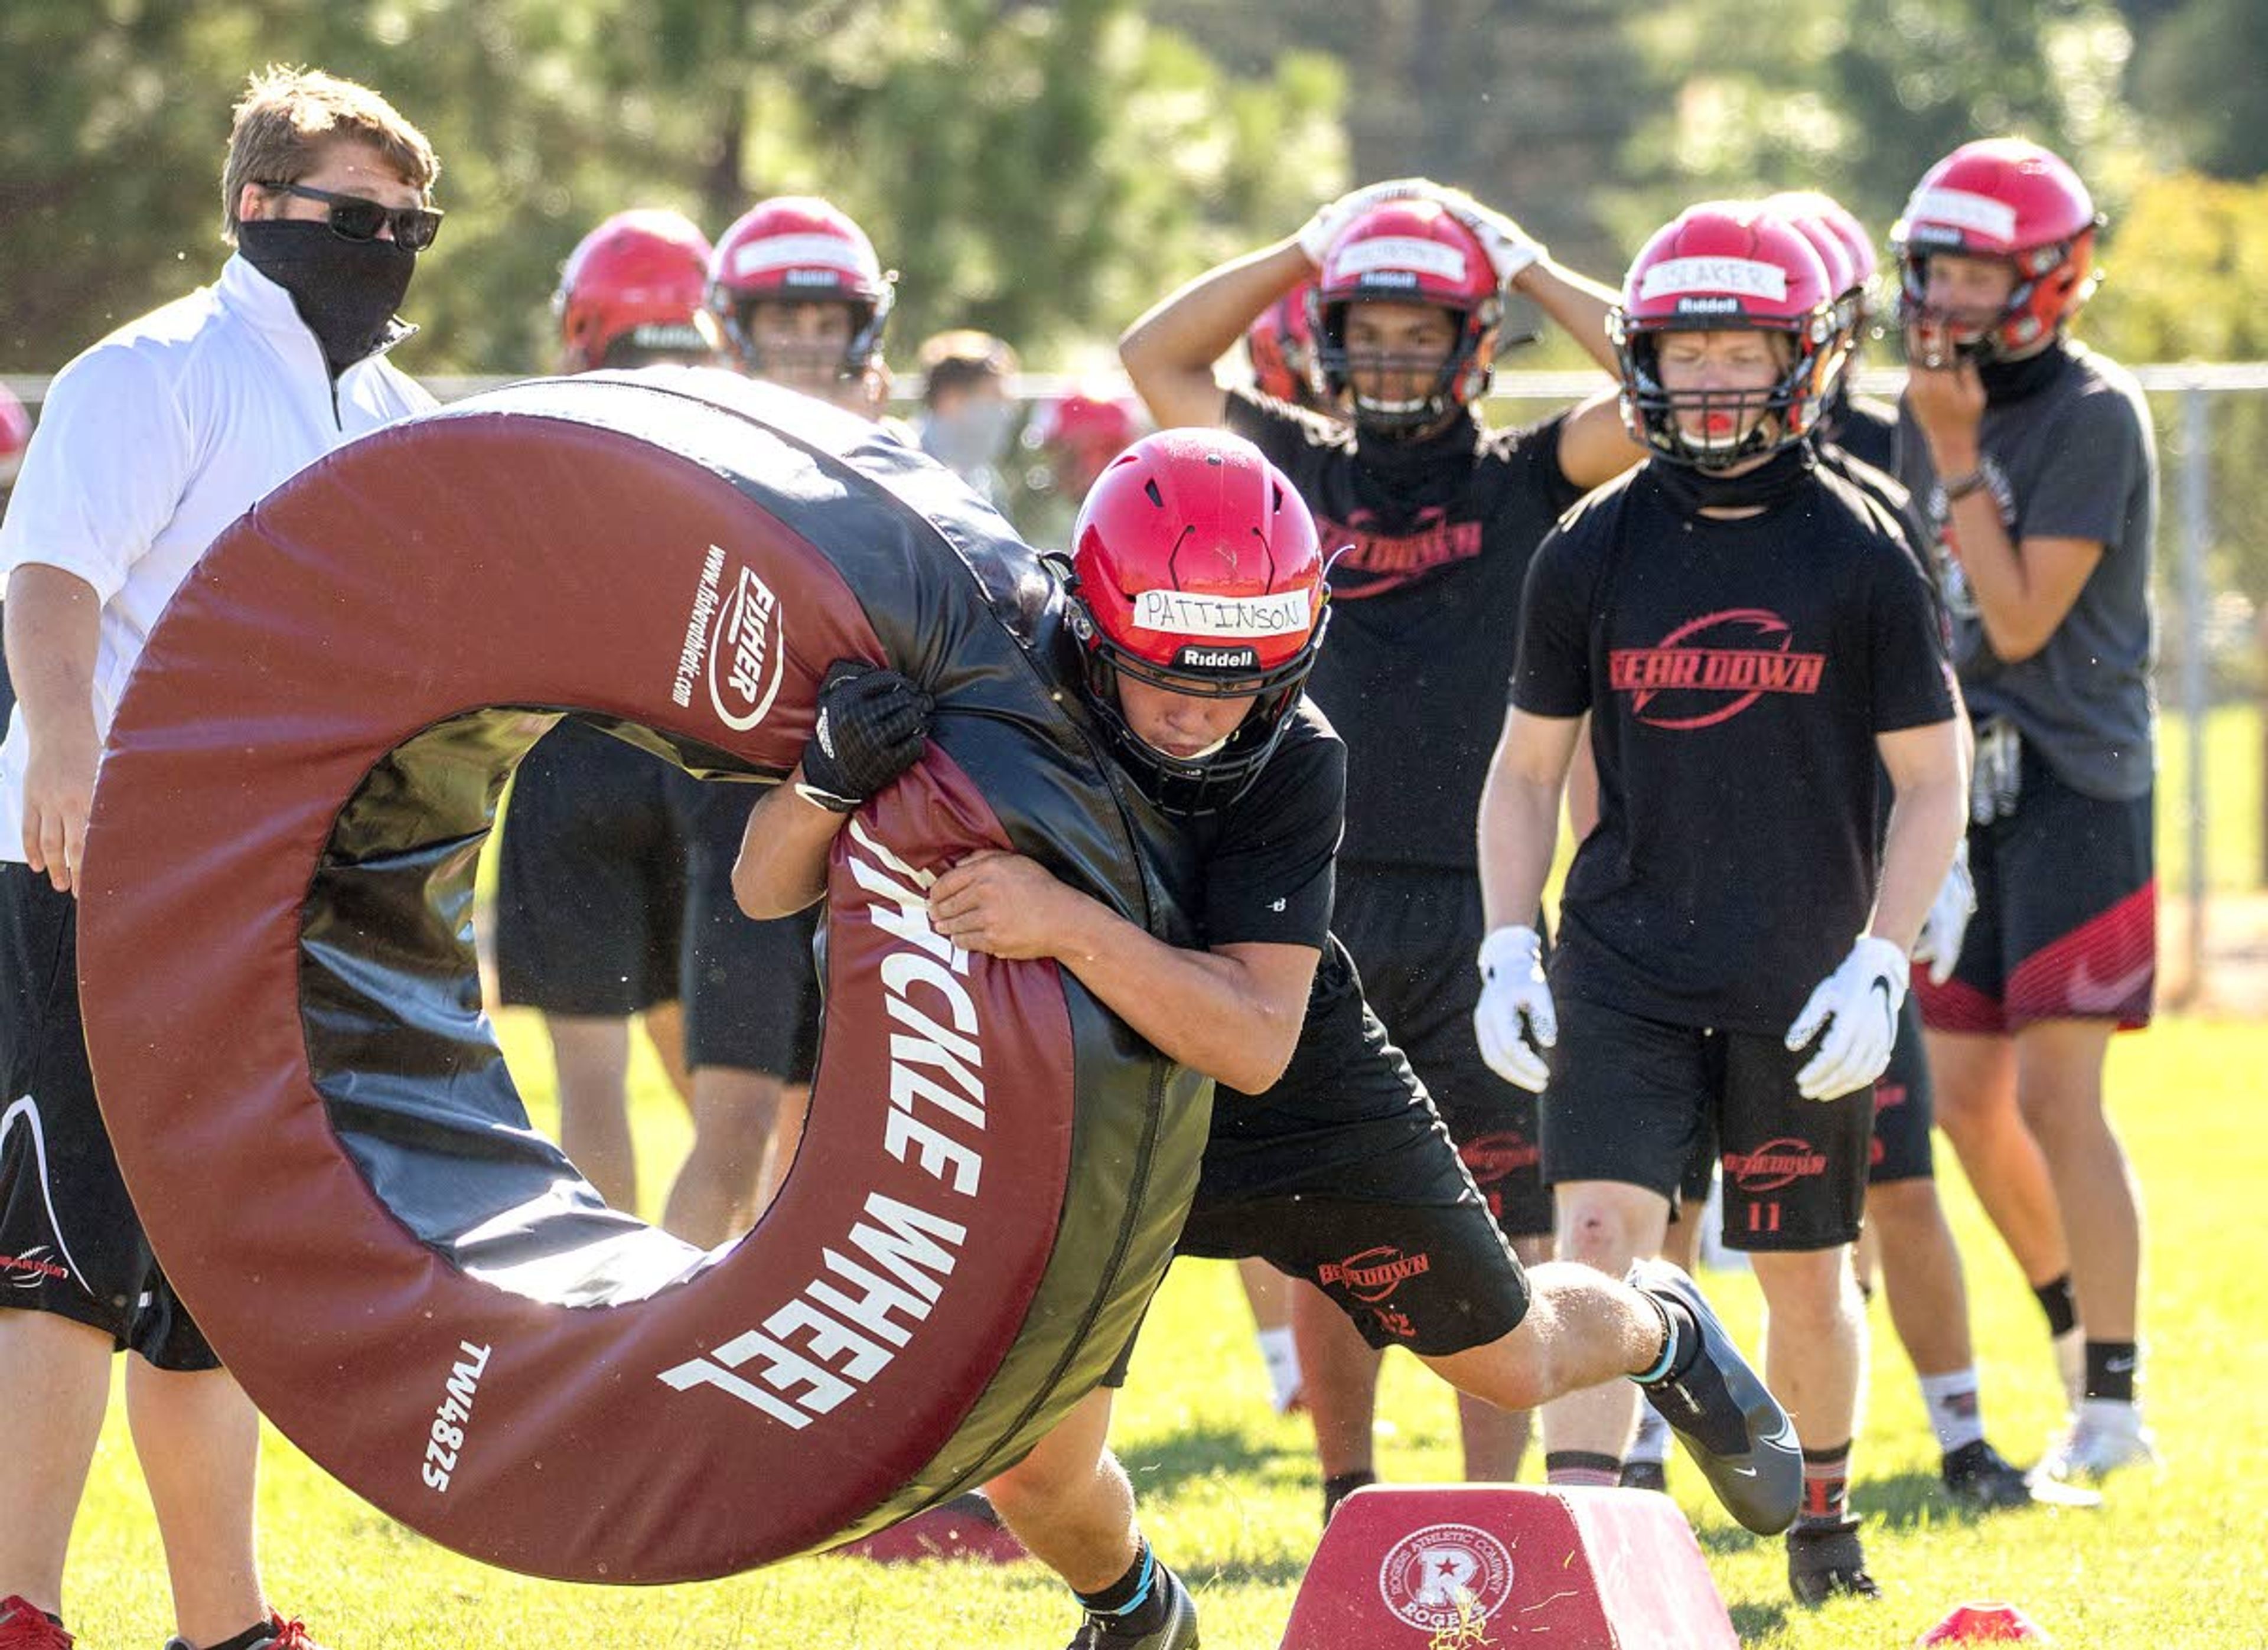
[0,1310,111,1616]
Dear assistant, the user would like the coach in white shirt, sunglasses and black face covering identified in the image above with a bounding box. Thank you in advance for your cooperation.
[0,70,440,1650]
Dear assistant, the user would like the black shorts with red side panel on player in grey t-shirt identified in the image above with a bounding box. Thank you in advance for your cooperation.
[1914,746,2157,1036]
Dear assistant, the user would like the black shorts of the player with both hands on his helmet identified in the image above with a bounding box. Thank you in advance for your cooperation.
[1331,861,1552,1238]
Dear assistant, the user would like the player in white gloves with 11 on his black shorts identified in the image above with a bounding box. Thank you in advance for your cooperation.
[1479,202,1966,1602]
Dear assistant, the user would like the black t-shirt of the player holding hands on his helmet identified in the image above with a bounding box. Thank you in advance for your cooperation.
[1225,390,1581,870]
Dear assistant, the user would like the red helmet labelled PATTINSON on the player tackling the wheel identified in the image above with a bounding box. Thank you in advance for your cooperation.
[1068,428,1329,814]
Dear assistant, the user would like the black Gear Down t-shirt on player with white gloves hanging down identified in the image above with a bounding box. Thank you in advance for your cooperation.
[1513,460,1953,1036]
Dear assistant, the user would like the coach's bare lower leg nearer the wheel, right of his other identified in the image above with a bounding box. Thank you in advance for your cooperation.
[127,1355,268,1645]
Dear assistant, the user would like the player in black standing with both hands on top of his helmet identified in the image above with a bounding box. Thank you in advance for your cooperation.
[1120,179,1640,1517]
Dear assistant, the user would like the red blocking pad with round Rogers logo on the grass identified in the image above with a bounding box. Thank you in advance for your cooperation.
[1282,1485,1739,1650]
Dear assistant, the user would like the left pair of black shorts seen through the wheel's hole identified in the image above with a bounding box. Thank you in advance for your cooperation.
[497,716,699,1020]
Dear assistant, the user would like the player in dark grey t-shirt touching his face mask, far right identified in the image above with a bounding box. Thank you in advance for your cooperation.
[1892,138,2157,1478]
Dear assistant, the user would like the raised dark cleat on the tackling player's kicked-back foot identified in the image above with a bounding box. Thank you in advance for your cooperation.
[1628,1260,1803,1534]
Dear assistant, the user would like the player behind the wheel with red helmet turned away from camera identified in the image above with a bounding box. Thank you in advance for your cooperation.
[497,208,719,1235]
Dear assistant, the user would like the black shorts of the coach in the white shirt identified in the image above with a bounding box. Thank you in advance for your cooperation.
[0,861,220,1369]
